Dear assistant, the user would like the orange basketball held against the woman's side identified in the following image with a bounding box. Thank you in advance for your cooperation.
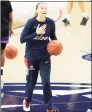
[47,40,63,56]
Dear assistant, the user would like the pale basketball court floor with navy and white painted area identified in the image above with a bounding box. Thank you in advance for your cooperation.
[1,2,92,112]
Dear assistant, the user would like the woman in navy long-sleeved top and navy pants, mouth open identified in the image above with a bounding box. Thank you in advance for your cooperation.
[20,2,57,112]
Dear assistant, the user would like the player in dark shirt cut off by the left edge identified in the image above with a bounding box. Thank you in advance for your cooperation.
[0,1,13,91]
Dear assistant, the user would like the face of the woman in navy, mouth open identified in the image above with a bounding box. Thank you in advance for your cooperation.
[36,3,47,17]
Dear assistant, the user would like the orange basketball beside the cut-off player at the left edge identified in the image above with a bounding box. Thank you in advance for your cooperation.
[4,45,18,60]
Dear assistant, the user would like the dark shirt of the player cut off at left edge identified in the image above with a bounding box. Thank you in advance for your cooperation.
[1,1,13,38]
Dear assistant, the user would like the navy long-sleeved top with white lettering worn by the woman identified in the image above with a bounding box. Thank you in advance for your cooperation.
[20,17,57,60]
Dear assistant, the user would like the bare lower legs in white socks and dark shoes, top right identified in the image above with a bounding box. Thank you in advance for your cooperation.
[62,1,89,26]
